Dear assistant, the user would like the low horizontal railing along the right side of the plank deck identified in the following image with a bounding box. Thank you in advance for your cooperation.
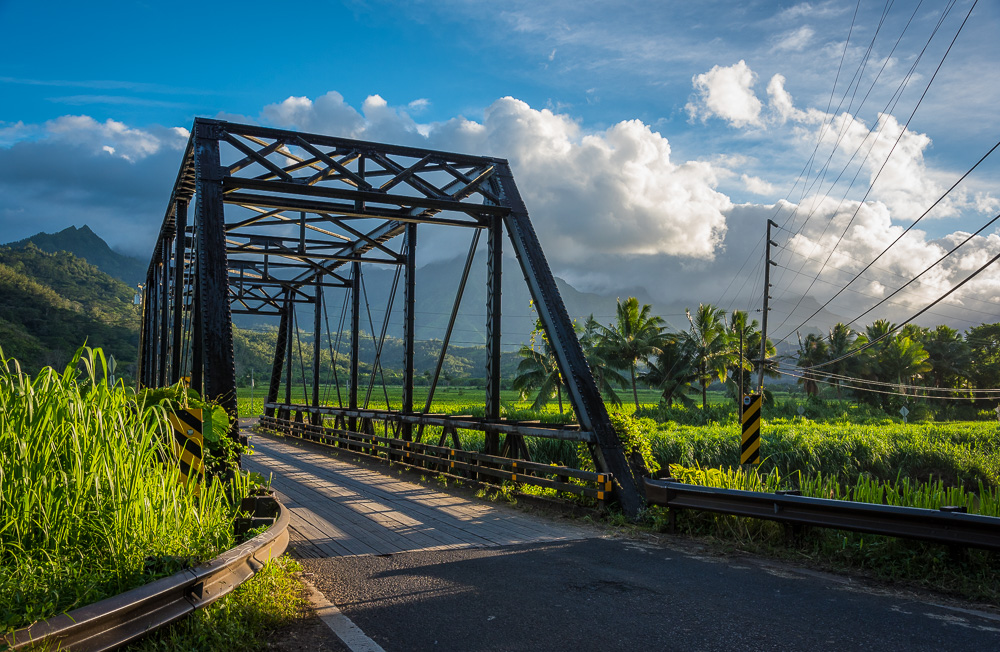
[258,416,614,503]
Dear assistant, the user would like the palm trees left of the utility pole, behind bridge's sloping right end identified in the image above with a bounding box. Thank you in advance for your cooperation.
[513,297,775,412]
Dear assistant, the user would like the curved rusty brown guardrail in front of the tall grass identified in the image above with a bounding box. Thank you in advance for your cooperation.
[0,499,289,652]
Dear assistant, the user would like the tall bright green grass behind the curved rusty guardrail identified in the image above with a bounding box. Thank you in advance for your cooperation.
[0,349,249,632]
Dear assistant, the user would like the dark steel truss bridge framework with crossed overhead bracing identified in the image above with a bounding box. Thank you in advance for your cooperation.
[138,118,644,515]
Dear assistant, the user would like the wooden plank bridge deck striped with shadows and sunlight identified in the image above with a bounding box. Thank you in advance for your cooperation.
[243,434,593,557]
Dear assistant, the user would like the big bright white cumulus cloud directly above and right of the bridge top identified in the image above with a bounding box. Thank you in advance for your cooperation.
[263,92,730,260]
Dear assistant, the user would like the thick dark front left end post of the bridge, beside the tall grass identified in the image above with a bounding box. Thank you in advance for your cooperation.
[194,118,239,439]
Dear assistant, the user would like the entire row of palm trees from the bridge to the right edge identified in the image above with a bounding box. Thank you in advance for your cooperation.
[513,297,1000,412]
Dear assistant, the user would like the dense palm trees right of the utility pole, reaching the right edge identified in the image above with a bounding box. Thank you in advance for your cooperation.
[796,319,1000,404]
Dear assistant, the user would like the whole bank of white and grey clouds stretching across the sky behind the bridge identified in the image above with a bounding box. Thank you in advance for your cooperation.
[0,69,1000,329]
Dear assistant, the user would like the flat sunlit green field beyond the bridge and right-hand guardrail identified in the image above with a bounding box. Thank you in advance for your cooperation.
[239,386,1000,490]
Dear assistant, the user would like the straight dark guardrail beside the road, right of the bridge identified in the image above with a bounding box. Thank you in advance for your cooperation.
[645,478,1000,550]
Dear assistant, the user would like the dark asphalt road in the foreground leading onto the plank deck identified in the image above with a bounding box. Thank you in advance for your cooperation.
[302,538,1000,652]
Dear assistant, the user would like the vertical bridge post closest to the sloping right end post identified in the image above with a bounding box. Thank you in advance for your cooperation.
[485,217,503,455]
